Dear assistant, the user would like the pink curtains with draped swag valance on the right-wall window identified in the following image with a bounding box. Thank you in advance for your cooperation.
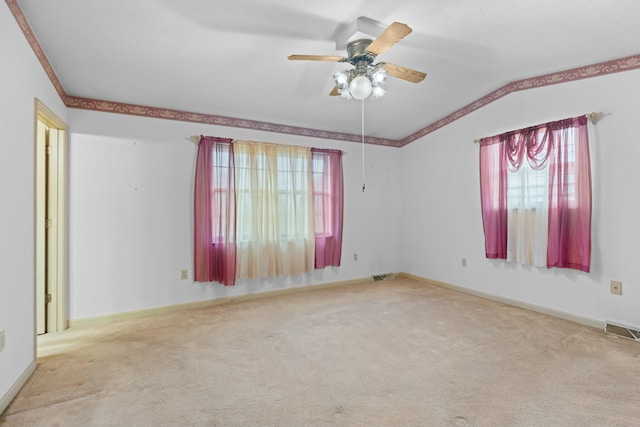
[480,116,591,272]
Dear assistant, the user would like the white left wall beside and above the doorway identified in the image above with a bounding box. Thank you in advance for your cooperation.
[0,5,66,412]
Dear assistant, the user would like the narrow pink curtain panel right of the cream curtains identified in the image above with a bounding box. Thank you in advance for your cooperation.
[311,148,344,269]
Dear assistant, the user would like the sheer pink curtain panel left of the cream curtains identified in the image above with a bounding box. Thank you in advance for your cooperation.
[193,136,236,286]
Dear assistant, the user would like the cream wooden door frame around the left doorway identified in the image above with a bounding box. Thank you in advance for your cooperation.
[34,98,69,336]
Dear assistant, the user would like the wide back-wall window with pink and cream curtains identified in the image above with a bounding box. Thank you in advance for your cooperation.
[194,137,342,285]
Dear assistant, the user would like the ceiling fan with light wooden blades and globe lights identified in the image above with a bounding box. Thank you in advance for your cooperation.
[288,22,427,100]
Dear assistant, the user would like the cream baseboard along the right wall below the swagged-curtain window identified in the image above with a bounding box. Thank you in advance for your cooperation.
[396,273,605,330]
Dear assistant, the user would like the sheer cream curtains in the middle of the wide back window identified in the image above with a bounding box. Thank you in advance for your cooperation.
[234,140,315,278]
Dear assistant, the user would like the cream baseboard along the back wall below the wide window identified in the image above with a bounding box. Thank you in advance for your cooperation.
[69,277,371,328]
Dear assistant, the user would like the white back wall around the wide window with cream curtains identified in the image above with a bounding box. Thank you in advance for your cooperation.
[69,109,400,320]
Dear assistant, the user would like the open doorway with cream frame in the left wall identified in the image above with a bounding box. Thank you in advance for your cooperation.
[35,99,68,335]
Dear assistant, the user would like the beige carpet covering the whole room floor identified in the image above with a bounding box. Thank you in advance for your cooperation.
[0,279,640,427]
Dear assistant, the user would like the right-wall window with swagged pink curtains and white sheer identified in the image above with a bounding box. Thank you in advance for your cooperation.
[480,116,591,271]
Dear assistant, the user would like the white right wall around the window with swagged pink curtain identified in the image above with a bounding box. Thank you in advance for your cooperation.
[399,71,640,326]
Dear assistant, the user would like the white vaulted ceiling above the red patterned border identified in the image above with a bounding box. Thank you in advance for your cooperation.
[17,0,640,145]
